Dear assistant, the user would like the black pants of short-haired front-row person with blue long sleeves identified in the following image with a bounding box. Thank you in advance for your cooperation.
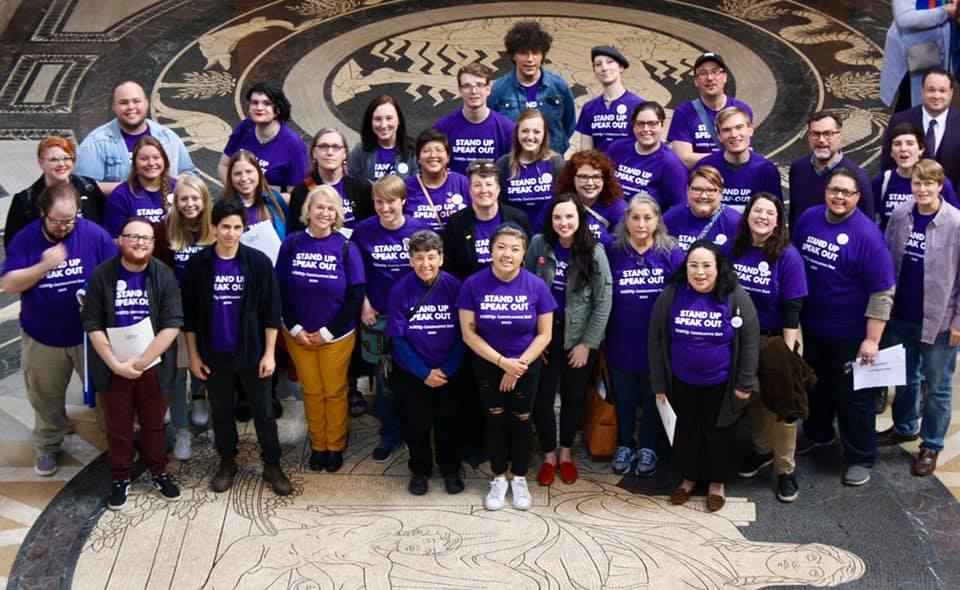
[390,365,460,477]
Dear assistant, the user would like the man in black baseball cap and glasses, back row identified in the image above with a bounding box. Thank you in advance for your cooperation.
[667,52,753,168]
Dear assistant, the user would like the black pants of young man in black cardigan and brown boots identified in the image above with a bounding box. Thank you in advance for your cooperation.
[207,353,280,465]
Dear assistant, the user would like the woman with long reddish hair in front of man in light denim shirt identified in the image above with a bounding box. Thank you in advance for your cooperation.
[103,135,176,237]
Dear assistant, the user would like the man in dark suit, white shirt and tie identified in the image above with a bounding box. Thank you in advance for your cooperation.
[880,67,960,186]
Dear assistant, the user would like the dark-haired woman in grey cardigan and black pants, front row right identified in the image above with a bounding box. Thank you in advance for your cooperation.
[648,240,760,512]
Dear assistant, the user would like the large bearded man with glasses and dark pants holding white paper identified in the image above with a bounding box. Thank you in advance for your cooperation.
[792,168,895,486]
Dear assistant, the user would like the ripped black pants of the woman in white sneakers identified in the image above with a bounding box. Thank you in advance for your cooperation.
[473,356,542,476]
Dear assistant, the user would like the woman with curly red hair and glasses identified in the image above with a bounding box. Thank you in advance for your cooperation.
[544,150,627,246]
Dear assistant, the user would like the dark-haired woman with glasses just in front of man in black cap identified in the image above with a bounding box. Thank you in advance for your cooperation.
[607,101,687,211]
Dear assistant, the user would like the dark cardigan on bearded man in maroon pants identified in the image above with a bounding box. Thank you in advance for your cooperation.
[80,256,183,392]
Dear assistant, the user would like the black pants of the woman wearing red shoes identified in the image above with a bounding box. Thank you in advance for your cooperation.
[533,322,597,453]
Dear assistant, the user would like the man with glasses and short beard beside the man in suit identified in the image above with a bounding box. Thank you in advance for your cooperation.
[788,111,874,227]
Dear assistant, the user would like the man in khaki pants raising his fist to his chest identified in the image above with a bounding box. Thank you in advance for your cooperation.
[0,182,117,476]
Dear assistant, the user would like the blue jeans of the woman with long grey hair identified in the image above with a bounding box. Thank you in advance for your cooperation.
[610,367,667,451]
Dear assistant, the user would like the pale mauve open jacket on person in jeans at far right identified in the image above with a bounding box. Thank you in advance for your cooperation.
[884,197,960,344]
